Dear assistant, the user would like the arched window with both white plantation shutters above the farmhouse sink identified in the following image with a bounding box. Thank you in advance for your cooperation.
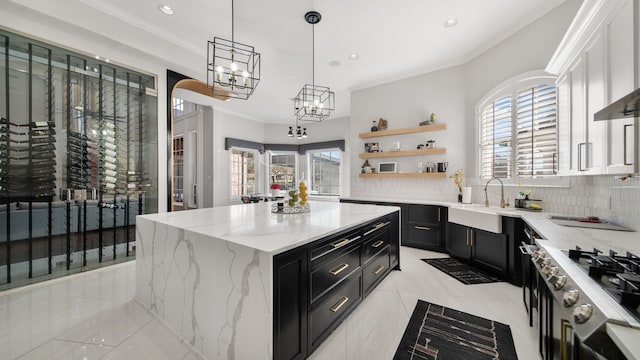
[480,78,557,179]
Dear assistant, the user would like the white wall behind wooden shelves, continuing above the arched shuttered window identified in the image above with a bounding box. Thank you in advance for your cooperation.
[349,0,581,201]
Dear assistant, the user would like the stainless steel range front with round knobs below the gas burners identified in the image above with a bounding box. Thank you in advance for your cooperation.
[522,243,626,360]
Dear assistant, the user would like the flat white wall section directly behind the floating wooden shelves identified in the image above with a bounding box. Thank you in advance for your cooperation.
[349,66,469,200]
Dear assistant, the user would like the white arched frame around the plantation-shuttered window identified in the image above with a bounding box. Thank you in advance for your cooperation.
[475,70,563,181]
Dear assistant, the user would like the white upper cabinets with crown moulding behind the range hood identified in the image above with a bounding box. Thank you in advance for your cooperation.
[546,0,640,175]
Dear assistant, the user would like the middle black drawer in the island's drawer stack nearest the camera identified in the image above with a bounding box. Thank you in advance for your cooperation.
[310,244,360,303]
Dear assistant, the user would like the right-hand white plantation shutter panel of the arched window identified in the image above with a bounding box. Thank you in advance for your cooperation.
[515,85,557,177]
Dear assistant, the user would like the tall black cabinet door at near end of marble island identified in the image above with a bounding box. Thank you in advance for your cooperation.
[273,247,308,360]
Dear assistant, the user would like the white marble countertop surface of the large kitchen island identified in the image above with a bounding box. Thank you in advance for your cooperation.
[139,201,400,255]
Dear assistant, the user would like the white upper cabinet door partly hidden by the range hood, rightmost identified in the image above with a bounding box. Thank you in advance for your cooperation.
[605,0,636,174]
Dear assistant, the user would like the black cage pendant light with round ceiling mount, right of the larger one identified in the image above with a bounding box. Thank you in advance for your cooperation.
[293,11,335,125]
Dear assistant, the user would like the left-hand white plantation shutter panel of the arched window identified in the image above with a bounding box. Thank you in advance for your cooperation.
[480,96,512,179]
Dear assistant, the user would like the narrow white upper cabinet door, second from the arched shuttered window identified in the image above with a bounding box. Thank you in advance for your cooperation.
[570,57,588,173]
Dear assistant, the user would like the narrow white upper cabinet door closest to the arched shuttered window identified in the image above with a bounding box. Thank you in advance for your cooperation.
[556,75,571,175]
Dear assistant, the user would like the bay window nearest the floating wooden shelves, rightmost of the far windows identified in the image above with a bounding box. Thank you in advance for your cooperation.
[308,150,342,196]
